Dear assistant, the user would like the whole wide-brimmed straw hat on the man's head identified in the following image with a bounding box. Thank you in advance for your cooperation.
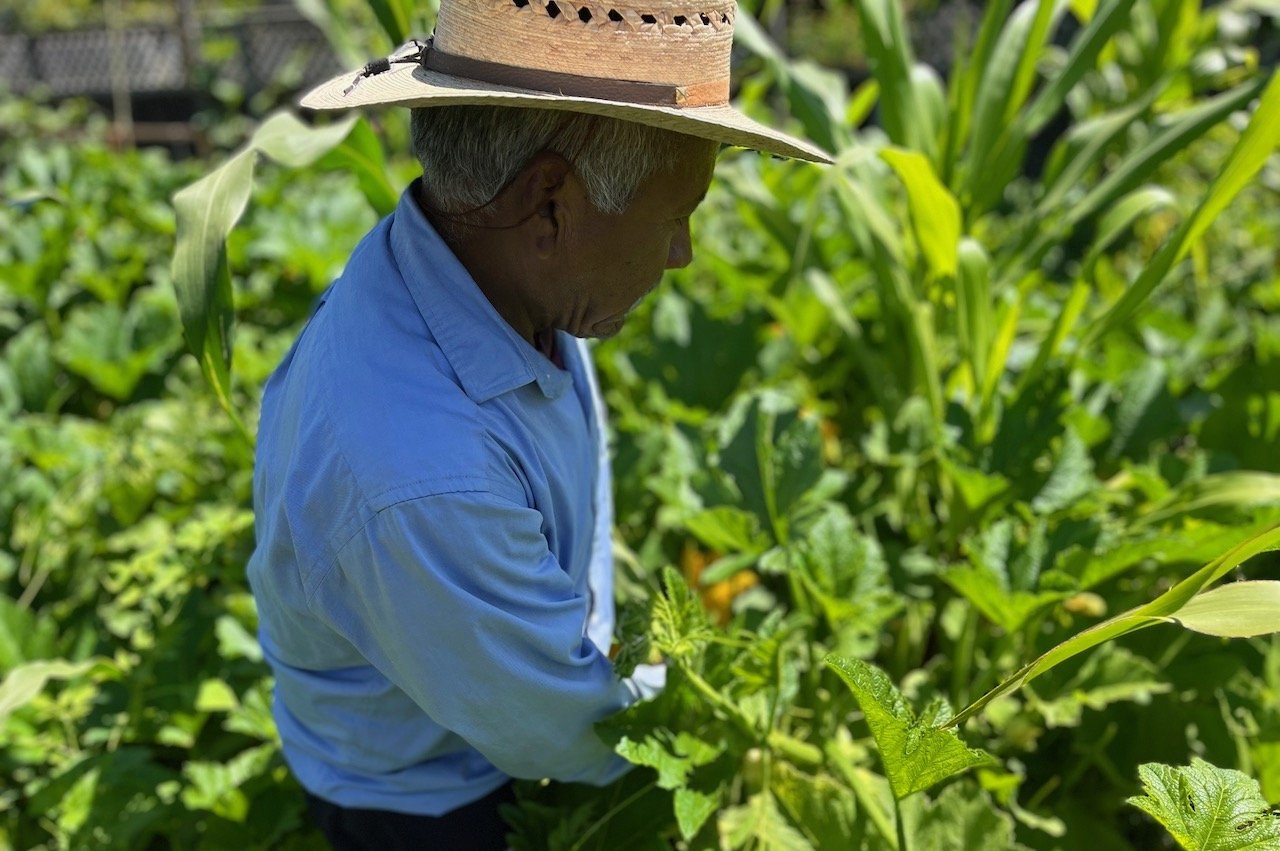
[300,0,832,164]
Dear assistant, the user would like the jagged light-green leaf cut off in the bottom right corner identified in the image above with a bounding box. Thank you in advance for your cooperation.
[1128,756,1280,851]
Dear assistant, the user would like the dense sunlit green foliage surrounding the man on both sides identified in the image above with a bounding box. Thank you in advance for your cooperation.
[0,0,1280,851]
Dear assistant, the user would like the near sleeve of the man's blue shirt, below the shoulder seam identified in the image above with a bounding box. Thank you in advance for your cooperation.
[312,481,652,786]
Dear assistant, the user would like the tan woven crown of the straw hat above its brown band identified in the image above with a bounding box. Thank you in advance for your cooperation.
[433,0,737,90]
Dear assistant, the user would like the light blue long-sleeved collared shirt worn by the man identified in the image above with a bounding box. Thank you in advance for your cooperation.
[248,177,664,815]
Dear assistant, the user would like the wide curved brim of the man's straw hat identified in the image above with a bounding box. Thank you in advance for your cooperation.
[298,63,835,164]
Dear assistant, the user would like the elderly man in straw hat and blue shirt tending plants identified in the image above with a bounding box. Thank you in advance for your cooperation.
[248,0,827,850]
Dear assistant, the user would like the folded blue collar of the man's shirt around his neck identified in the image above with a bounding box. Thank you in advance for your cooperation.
[390,178,573,404]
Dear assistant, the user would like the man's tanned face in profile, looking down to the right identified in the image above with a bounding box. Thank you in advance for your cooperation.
[548,138,719,338]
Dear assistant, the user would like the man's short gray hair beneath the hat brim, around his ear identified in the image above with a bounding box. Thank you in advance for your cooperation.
[410,105,714,236]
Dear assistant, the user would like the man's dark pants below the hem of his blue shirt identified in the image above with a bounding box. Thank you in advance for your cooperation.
[303,781,516,851]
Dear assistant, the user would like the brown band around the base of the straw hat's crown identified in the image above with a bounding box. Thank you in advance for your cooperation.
[422,46,730,106]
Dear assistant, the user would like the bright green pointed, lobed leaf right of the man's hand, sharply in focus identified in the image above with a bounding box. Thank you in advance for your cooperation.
[823,654,995,799]
